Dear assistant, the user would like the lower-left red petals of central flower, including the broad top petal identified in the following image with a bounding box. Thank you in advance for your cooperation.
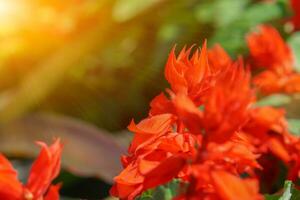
[110,110,197,199]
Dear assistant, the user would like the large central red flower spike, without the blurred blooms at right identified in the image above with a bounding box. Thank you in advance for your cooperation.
[111,41,276,200]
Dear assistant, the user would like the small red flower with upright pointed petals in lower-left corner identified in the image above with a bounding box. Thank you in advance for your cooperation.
[0,139,62,200]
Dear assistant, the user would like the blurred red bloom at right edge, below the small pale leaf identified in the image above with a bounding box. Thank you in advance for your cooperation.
[243,107,300,187]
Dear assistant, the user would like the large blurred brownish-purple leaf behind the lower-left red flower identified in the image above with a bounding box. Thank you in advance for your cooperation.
[0,114,126,183]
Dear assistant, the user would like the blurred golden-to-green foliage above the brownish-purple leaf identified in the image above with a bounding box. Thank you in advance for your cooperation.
[0,0,287,131]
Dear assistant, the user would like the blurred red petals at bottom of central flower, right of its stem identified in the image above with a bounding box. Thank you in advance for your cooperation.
[179,131,262,200]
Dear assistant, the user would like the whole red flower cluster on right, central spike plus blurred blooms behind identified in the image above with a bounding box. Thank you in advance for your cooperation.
[111,26,300,200]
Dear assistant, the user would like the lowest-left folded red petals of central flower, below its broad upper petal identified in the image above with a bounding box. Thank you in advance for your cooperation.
[110,132,196,200]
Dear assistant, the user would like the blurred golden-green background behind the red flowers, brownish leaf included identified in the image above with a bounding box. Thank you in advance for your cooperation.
[0,0,300,199]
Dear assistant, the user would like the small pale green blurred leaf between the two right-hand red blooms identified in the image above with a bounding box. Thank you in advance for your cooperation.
[256,94,291,106]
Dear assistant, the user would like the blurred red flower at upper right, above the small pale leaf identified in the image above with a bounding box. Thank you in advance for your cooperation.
[247,26,300,93]
